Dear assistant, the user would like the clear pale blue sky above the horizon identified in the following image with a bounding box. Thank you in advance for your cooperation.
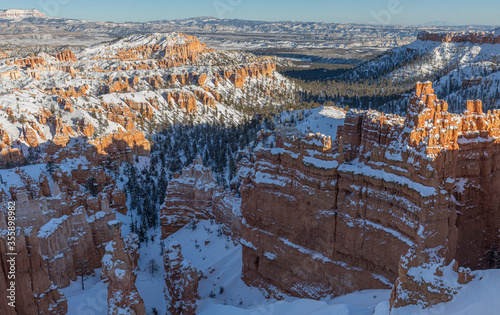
[0,0,500,25]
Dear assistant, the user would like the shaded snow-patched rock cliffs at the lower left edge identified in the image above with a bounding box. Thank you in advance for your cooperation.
[0,165,131,314]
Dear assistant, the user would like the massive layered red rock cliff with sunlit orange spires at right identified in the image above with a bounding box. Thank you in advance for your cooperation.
[241,83,500,306]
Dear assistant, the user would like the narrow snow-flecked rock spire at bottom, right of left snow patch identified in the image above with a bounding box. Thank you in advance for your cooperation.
[102,221,146,315]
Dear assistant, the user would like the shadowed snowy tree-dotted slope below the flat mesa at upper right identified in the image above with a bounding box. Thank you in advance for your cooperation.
[344,31,500,115]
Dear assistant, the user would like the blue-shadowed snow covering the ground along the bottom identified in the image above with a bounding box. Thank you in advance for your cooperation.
[63,217,500,315]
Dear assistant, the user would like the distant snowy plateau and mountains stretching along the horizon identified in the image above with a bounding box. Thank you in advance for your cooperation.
[0,9,491,63]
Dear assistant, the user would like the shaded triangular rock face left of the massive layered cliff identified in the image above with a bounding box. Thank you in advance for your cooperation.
[160,158,240,239]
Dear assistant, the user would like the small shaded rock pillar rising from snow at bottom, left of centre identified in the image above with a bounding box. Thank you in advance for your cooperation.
[163,242,200,315]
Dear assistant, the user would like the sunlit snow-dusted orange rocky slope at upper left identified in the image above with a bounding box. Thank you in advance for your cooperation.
[0,34,294,165]
